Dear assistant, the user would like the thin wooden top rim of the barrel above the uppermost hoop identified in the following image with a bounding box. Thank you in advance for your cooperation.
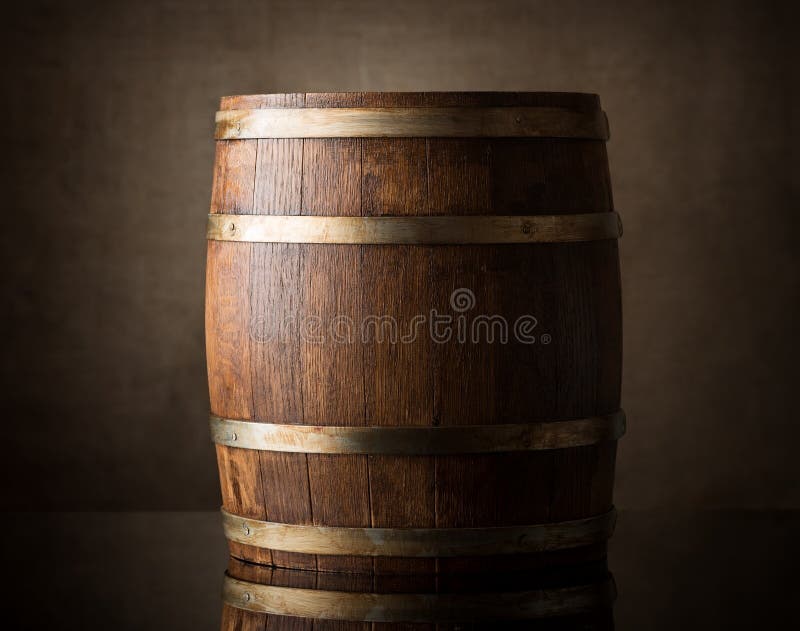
[220,90,600,110]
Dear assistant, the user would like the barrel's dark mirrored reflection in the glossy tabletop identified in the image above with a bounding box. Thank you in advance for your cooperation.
[222,559,617,631]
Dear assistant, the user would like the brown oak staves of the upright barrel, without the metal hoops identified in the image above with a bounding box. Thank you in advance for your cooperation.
[207,93,621,574]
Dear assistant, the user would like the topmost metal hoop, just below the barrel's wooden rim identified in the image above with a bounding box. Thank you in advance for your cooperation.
[214,107,609,140]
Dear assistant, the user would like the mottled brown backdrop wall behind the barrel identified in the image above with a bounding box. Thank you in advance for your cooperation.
[0,0,800,509]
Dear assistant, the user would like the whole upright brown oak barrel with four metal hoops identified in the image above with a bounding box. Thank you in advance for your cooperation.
[206,92,624,573]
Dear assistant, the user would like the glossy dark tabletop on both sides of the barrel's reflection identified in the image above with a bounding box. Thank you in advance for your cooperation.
[3,510,800,630]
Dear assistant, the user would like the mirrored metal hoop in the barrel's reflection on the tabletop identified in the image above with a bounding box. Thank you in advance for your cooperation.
[222,575,617,623]
